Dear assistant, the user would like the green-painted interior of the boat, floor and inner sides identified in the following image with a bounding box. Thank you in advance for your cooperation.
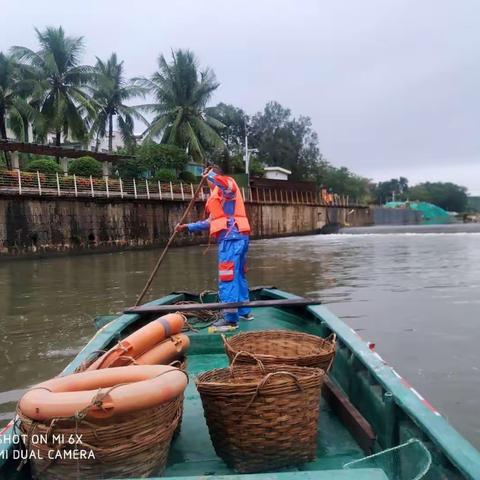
[0,288,468,480]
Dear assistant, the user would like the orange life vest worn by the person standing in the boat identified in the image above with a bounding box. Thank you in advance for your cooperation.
[205,177,250,236]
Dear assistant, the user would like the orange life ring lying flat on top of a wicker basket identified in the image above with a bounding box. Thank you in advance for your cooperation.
[19,365,188,420]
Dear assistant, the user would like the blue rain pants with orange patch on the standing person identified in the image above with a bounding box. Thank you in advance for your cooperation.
[218,235,250,324]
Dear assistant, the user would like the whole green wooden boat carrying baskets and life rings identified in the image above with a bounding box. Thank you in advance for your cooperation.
[0,288,480,480]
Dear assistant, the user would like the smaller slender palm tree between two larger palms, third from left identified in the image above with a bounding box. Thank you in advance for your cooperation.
[92,53,148,153]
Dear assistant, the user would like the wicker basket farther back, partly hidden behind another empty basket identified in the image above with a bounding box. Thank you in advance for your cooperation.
[222,330,336,372]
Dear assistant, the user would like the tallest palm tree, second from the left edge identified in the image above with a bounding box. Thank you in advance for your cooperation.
[12,27,94,146]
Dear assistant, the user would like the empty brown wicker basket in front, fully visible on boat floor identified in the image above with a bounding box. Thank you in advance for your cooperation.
[196,357,325,473]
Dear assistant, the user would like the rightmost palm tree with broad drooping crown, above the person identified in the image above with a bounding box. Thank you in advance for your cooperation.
[137,50,224,161]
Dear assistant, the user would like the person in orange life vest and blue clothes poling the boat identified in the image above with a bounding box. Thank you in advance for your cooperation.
[175,166,253,330]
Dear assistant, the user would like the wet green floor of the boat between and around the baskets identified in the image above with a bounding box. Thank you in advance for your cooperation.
[164,308,364,477]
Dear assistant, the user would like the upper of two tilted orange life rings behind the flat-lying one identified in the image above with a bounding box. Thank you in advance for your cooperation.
[87,313,185,370]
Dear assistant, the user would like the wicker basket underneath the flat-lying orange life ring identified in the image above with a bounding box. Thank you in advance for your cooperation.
[16,395,183,480]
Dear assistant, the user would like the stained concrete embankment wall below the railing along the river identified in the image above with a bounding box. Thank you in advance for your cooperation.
[0,196,416,258]
